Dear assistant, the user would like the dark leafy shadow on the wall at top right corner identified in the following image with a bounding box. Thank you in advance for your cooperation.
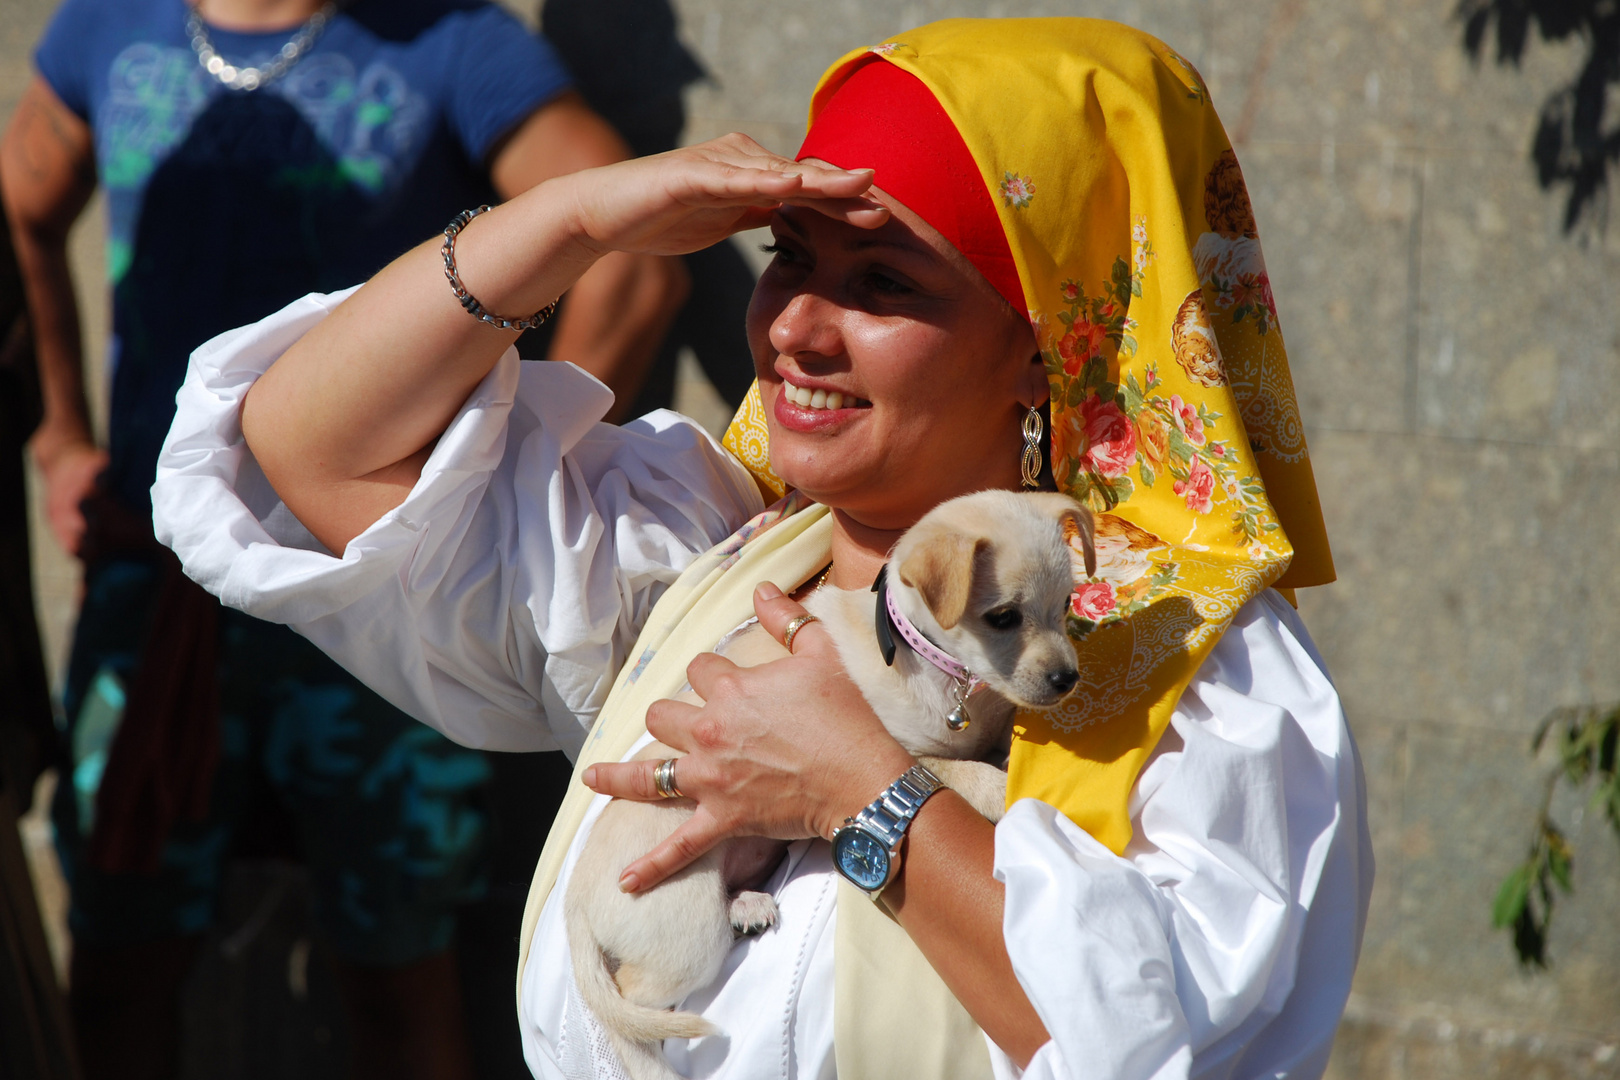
[1456,0,1620,233]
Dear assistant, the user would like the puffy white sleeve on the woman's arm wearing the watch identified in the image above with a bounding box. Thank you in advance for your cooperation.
[991,593,1372,1080]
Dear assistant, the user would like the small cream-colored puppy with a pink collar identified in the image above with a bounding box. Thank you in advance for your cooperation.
[564,491,1095,1080]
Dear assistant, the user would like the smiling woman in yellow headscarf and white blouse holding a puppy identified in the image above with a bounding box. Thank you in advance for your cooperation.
[154,19,1372,1078]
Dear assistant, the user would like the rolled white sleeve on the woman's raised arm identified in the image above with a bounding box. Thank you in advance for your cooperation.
[152,293,763,756]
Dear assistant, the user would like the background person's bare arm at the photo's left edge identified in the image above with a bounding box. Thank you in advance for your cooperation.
[0,76,107,552]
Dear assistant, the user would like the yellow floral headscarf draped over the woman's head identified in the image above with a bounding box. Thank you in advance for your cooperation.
[726,18,1333,852]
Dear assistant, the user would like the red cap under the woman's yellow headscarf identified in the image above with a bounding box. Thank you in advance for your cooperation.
[799,57,1027,316]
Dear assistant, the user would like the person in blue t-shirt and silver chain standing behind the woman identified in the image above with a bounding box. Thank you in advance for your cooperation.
[0,0,685,1080]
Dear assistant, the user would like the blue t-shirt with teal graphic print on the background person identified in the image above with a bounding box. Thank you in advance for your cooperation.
[36,0,569,510]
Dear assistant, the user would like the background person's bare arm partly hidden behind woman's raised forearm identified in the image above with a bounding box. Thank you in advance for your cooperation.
[489,92,690,423]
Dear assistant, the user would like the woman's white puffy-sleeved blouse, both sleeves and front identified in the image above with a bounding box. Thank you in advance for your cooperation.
[152,295,1372,1080]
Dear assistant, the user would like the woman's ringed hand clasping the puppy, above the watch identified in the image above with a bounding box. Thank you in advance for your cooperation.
[583,585,915,892]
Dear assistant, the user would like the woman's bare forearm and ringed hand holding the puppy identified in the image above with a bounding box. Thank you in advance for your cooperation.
[583,585,1048,1067]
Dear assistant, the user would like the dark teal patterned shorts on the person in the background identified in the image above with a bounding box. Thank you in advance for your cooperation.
[52,560,491,967]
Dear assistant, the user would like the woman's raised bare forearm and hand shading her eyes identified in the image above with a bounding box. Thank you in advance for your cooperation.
[241,136,888,551]
